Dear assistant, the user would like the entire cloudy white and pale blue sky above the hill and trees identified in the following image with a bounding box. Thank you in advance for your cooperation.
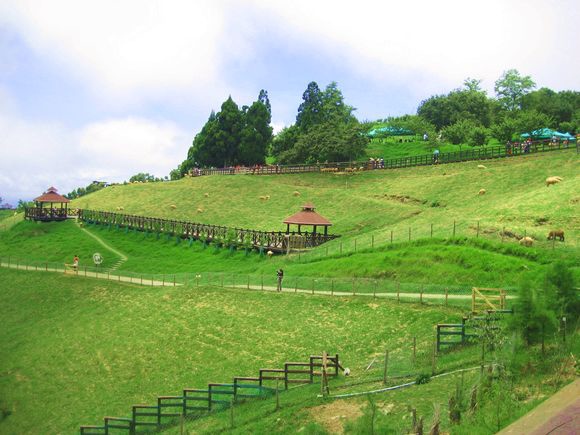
[0,0,580,202]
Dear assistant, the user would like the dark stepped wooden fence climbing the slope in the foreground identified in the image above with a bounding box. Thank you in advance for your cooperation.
[80,354,343,435]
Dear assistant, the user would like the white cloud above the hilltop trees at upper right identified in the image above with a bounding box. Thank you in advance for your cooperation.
[254,0,580,93]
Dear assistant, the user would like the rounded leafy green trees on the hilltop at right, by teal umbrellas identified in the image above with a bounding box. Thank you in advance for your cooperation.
[375,69,580,146]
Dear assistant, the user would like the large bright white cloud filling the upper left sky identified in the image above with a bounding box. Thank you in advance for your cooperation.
[0,0,233,103]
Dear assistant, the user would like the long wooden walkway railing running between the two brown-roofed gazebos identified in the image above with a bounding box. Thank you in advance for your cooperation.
[77,209,339,252]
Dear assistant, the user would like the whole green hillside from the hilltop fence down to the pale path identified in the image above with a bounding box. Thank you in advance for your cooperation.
[0,151,580,289]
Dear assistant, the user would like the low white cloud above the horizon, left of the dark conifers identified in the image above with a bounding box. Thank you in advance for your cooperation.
[0,95,189,201]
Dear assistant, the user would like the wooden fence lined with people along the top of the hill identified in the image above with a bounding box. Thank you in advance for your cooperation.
[192,140,578,176]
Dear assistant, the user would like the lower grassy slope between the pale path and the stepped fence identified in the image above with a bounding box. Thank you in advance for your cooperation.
[0,269,459,433]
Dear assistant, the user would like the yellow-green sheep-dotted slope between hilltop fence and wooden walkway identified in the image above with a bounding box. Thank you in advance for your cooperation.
[73,151,580,245]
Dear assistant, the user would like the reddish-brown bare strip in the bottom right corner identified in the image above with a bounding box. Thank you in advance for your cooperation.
[498,379,580,435]
